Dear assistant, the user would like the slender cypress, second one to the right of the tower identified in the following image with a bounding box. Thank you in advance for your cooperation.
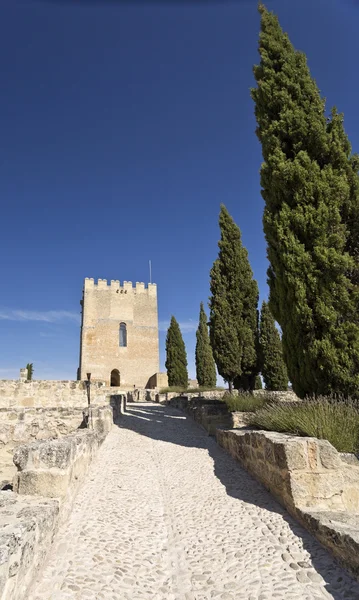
[196,302,217,387]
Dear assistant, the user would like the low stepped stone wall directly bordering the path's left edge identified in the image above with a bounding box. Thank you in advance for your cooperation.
[0,404,117,600]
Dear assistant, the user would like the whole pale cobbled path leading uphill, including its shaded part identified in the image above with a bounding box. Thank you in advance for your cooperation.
[29,404,359,600]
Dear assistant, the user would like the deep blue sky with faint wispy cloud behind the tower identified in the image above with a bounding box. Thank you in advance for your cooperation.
[0,0,359,379]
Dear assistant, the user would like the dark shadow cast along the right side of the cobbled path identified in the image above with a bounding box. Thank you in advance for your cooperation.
[118,403,359,600]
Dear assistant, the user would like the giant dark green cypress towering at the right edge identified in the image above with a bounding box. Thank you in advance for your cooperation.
[252,5,359,397]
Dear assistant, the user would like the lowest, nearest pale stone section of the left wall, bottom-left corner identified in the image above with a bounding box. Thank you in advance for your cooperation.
[0,492,59,600]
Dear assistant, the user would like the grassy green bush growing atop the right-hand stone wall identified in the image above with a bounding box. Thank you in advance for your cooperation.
[249,396,359,453]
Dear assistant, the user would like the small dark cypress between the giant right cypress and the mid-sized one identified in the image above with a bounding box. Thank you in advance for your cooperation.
[259,302,288,391]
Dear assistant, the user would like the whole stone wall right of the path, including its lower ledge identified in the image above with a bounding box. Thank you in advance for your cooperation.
[217,429,359,577]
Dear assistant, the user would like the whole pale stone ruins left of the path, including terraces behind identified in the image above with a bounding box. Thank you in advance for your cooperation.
[0,369,126,600]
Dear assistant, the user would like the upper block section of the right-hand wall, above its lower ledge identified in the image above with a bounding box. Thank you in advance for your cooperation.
[217,429,359,514]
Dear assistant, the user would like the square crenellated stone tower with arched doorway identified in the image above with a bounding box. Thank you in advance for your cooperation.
[78,278,159,388]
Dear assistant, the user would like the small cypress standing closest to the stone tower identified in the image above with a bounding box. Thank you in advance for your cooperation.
[166,316,188,388]
